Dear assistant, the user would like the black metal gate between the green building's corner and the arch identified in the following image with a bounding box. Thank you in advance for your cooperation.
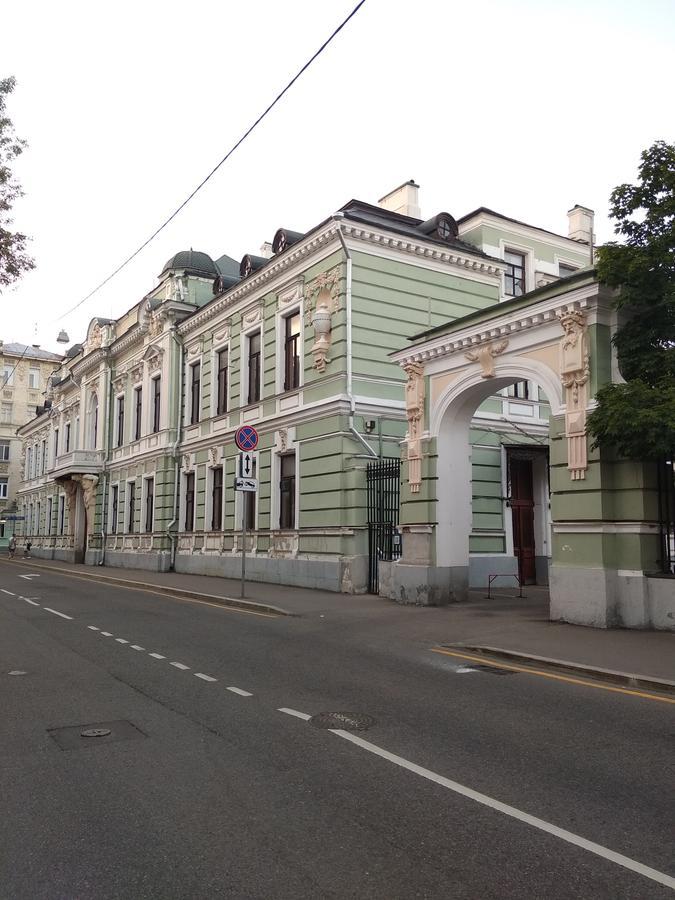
[366,459,401,594]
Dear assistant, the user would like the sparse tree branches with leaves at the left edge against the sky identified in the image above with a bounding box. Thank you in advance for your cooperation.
[0,78,35,291]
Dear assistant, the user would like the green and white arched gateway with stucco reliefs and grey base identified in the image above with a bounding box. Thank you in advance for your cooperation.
[380,272,675,629]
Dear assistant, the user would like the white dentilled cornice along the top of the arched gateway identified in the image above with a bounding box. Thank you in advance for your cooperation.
[391,283,598,366]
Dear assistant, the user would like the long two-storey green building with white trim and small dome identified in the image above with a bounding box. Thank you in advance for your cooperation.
[15,182,672,628]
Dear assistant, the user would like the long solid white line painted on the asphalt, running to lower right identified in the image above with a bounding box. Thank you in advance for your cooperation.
[332,732,675,889]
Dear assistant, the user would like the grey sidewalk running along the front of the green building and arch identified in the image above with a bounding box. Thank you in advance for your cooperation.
[6,559,675,683]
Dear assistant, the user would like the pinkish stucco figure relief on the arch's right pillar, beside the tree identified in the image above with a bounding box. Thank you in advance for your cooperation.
[558,310,590,481]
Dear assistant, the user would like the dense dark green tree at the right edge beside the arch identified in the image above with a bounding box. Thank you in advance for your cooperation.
[588,141,675,459]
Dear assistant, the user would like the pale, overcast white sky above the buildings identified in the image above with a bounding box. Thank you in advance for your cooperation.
[0,0,675,350]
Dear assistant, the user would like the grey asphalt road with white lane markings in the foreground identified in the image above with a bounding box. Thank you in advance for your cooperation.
[0,561,675,900]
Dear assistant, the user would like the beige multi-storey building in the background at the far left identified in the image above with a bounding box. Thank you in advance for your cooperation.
[0,341,61,547]
